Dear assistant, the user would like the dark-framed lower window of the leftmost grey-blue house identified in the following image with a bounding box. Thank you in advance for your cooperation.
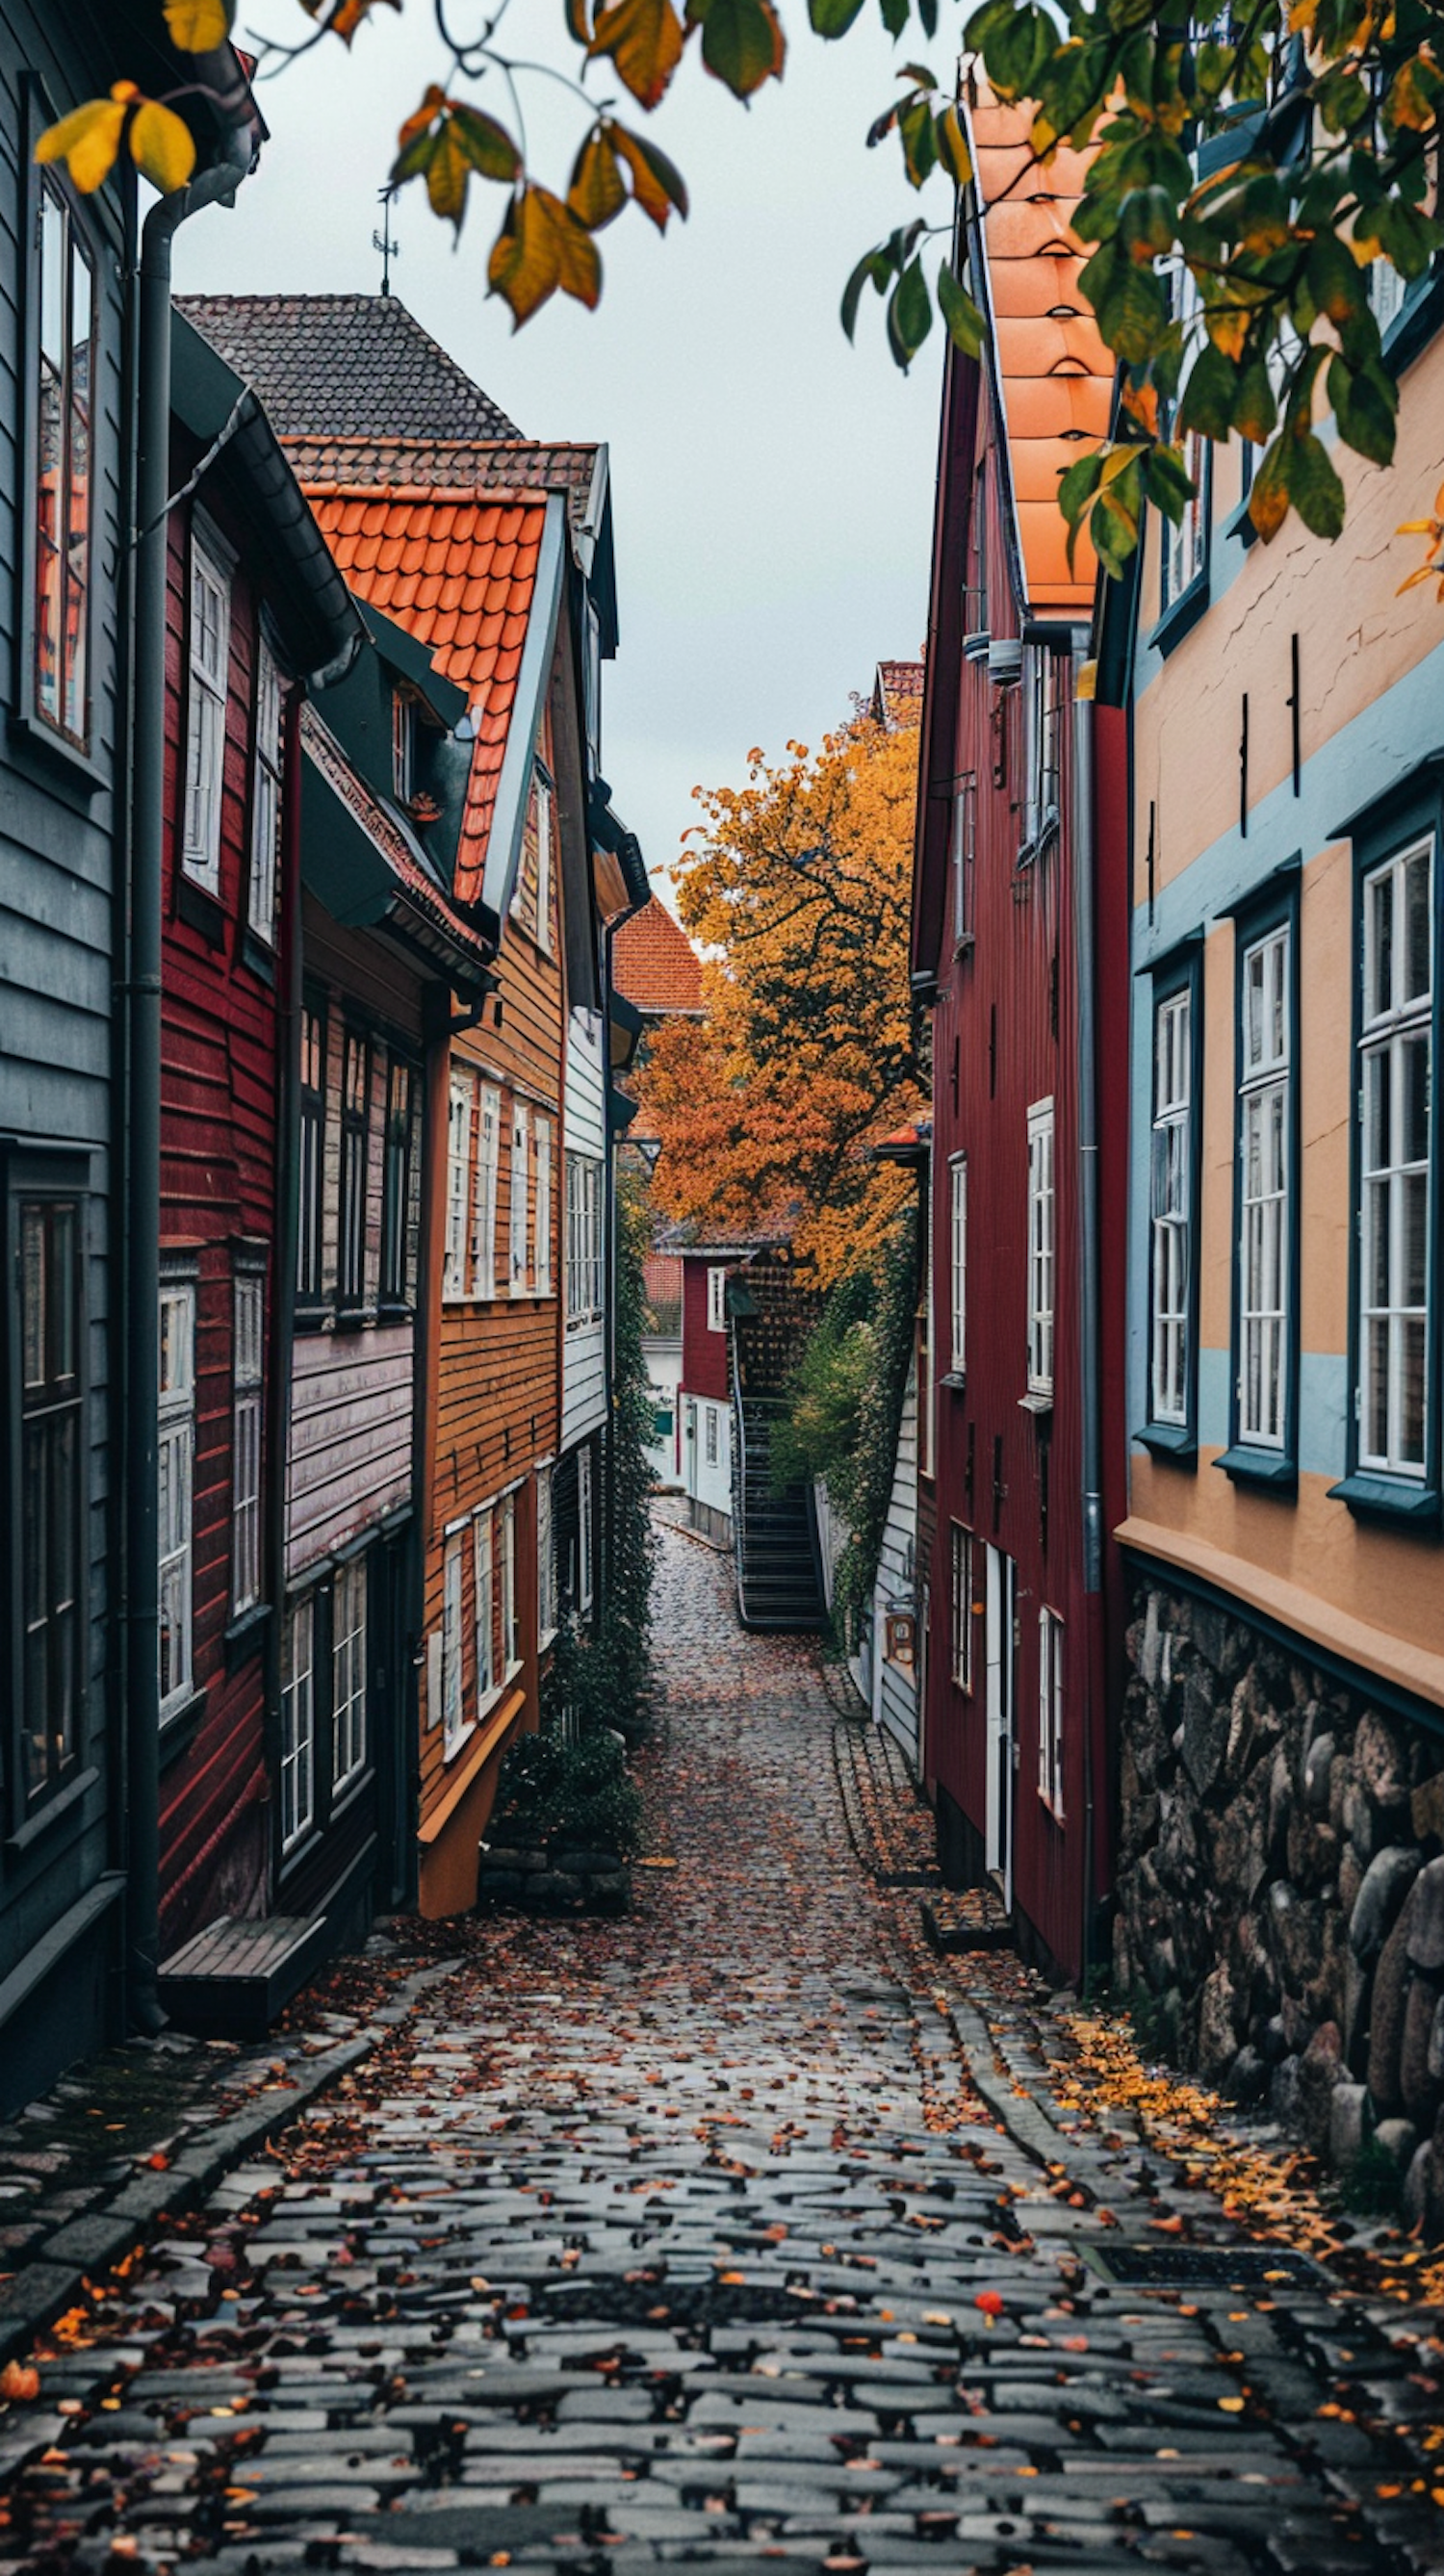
[13,1198,83,1798]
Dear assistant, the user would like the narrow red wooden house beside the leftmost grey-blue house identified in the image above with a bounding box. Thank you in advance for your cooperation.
[160,317,363,1955]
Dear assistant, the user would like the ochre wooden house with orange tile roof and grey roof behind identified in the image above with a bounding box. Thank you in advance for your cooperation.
[173,296,631,1914]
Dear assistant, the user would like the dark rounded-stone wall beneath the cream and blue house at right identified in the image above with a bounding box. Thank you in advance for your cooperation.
[1115,1579,1444,2233]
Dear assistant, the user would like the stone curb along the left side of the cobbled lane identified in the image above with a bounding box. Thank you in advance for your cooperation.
[0,1960,461,2362]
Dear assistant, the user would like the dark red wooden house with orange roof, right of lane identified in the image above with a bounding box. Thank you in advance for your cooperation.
[912,103,1127,1975]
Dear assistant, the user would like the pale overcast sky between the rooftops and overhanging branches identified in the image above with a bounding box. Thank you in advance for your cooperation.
[175,0,947,912]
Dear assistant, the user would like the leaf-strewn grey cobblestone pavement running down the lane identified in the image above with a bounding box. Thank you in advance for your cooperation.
[0,1533,1444,2576]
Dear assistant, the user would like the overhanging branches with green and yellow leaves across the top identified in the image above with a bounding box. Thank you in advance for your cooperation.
[39,0,1444,577]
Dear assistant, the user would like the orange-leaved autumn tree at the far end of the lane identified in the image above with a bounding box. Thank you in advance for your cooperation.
[632,716,927,1285]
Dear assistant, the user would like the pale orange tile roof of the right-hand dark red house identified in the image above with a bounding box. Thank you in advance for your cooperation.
[967,92,1115,613]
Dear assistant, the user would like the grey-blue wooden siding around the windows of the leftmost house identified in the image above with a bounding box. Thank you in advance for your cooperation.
[0,0,123,2102]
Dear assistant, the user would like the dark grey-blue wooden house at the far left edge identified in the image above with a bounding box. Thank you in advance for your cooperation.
[0,0,260,2104]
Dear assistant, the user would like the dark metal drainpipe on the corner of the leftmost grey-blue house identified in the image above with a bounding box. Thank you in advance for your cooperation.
[123,141,252,2035]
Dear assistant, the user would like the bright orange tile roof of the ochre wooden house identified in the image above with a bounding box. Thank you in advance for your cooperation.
[304,481,546,902]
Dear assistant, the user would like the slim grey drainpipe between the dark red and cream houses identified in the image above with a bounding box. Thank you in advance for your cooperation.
[1073,654,1104,1989]
